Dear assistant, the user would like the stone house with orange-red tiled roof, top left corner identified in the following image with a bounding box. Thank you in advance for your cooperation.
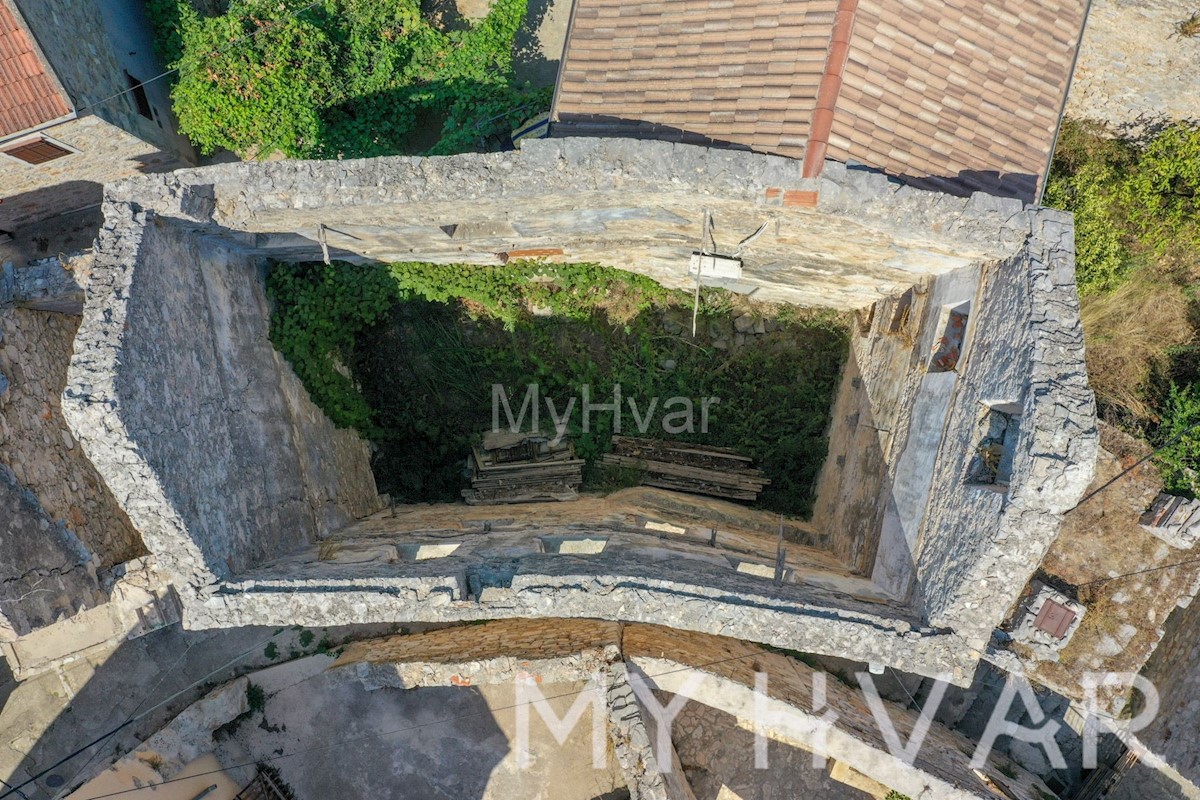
[0,0,194,237]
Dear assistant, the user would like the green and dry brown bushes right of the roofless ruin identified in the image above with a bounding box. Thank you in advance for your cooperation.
[1045,120,1200,495]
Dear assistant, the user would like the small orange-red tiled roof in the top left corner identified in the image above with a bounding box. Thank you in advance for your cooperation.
[0,0,71,137]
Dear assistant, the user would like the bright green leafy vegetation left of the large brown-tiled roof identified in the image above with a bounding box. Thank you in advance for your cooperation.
[148,0,550,158]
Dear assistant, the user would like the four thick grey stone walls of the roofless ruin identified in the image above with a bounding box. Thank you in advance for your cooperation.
[64,139,1097,682]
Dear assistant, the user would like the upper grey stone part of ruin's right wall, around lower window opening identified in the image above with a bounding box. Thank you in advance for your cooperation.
[916,210,1099,643]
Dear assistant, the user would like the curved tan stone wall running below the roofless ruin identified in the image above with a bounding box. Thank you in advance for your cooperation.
[334,620,1044,800]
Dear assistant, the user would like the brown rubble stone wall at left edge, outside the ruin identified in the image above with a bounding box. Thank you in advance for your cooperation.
[0,303,145,567]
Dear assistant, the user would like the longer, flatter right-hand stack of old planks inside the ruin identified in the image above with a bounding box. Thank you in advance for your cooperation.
[601,437,770,500]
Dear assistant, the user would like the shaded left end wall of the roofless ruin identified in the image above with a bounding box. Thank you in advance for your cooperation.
[65,211,379,588]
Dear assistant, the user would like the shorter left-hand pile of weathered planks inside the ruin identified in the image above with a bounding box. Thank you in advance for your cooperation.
[462,431,583,505]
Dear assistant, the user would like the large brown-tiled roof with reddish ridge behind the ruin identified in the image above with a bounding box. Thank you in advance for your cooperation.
[553,0,1087,199]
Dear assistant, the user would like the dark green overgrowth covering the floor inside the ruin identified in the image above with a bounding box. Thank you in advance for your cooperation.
[268,261,847,515]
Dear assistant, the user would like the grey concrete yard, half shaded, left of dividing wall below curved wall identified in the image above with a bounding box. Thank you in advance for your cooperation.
[217,669,624,800]
